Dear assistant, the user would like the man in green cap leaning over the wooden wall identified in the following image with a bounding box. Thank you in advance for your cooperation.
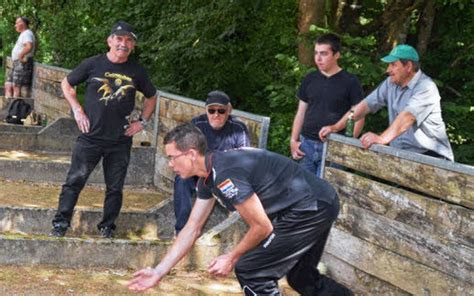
[320,44,454,161]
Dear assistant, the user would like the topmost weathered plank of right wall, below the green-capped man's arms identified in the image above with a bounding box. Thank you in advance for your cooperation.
[326,141,474,209]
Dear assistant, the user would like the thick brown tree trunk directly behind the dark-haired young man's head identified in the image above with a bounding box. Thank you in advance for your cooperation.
[298,0,326,66]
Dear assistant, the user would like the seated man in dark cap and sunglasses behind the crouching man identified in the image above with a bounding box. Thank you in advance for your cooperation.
[173,90,250,234]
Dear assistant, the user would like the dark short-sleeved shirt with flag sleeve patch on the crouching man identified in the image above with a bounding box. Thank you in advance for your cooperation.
[197,148,336,216]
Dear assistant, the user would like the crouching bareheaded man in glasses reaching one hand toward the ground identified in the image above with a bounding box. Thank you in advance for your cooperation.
[128,124,351,295]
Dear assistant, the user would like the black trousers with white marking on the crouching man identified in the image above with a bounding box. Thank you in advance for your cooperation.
[235,198,350,296]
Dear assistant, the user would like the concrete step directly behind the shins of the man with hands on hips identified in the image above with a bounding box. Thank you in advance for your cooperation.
[0,179,228,239]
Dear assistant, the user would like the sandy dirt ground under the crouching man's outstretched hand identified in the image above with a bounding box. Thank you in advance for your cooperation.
[0,266,297,296]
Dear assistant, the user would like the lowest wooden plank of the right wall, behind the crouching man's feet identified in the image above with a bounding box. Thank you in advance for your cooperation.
[321,253,411,296]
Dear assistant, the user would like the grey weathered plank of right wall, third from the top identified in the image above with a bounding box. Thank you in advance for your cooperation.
[337,204,474,284]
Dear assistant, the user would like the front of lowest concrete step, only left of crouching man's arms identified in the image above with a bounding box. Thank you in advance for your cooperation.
[0,235,169,268]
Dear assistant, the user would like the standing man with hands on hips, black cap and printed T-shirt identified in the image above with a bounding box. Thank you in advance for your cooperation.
[51,21,156,238]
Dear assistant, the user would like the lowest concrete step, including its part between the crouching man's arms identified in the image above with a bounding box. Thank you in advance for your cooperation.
[0,211,241,269]
